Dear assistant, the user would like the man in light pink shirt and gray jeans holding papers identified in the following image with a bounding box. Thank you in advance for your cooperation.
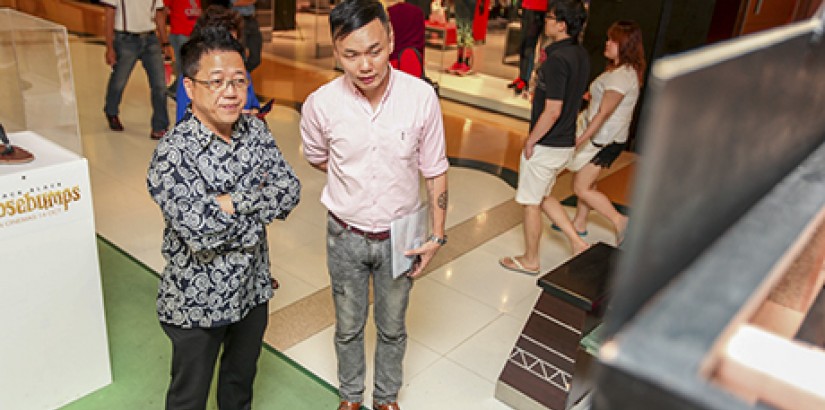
[301,0,449,410]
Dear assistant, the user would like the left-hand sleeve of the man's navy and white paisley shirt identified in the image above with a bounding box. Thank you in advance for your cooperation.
[147,139,265,252]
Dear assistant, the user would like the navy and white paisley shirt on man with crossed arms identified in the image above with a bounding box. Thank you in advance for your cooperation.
[147,111,301,328]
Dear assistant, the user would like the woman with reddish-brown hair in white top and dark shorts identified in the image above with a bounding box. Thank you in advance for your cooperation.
[567,21,645,244]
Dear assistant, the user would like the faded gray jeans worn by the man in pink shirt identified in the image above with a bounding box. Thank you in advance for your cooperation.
[327,218,413,404]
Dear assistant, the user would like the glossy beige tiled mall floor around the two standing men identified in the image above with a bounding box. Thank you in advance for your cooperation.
[71,33,632,410]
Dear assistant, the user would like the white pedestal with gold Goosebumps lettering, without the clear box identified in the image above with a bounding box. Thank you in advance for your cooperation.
[0,132,112,410]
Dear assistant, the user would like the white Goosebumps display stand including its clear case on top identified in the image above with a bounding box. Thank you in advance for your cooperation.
[0,9,112,410]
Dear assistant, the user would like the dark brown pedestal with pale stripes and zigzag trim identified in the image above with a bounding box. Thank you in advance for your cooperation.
[496,243,617,410]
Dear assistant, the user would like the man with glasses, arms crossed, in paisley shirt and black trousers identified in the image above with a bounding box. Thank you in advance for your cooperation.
[147,27,300,410]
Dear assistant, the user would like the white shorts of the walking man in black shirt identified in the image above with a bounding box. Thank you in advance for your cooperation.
[516,145,573,205]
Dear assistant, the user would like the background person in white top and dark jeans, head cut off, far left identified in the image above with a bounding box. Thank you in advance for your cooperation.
[101,0,173,139]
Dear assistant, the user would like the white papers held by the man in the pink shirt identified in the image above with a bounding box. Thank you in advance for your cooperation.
[390,206,429,279]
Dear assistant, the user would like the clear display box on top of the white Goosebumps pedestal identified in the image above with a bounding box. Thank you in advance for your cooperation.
[0,8,81,156]
